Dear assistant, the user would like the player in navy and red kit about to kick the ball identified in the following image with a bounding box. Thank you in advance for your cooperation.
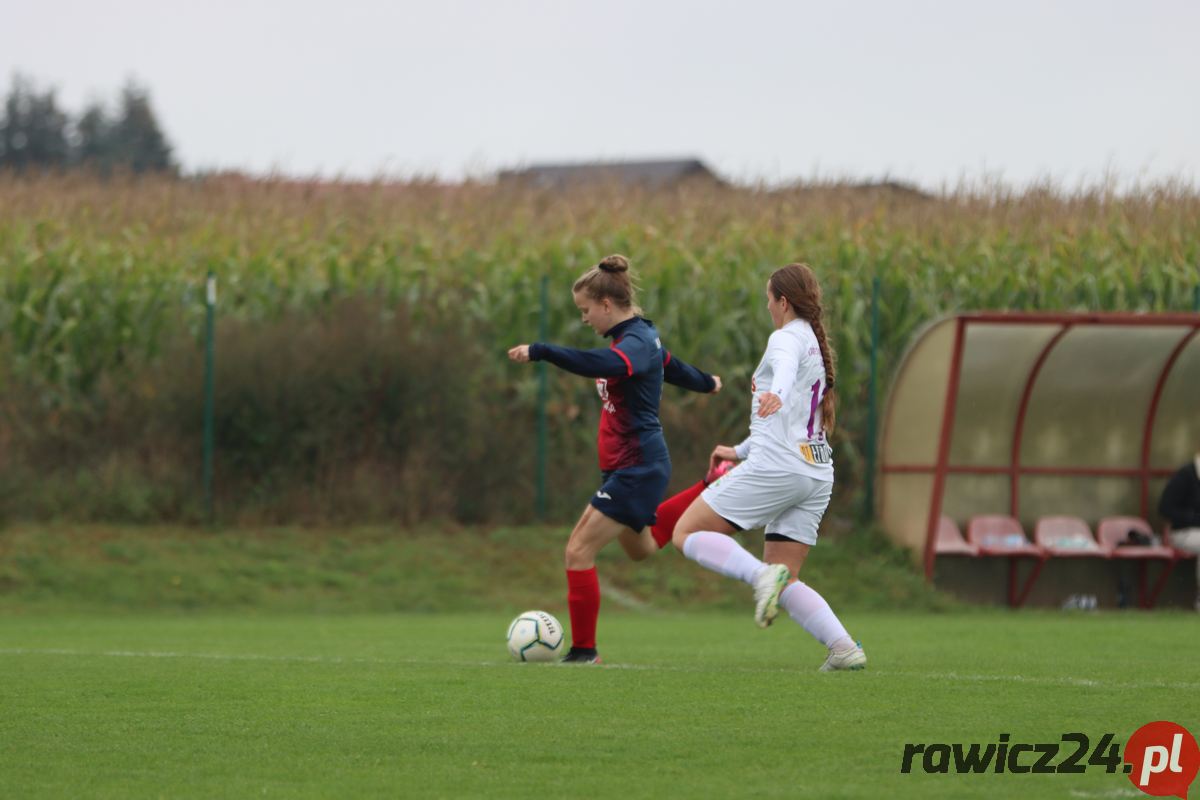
[509,255,721,663]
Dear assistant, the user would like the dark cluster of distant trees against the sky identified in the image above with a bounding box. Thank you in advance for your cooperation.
[0,74,176,174]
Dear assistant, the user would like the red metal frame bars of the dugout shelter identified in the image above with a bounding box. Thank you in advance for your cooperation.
[902,312,1200,582]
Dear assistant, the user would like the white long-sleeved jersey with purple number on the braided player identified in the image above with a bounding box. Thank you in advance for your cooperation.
[736,319,833,481]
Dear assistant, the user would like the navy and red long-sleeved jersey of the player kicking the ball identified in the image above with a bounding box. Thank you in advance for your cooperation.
[529,317,716,471]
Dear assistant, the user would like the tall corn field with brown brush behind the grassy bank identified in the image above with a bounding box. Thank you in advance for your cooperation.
[0,176,1200,523]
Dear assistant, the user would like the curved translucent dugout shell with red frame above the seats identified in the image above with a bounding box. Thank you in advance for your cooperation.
[878,312,1200,604]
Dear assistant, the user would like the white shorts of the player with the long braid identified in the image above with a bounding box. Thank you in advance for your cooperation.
[700,461,833,545]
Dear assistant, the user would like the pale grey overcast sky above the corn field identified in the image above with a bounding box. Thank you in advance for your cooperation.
[0,0,1200,187]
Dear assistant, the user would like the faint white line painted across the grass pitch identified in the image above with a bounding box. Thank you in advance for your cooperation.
[0,648,1200,691]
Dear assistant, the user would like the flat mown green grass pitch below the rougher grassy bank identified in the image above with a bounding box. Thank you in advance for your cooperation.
[0,608,1200,799]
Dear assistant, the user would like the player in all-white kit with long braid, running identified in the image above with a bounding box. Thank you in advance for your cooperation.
[673,264,866,672]
